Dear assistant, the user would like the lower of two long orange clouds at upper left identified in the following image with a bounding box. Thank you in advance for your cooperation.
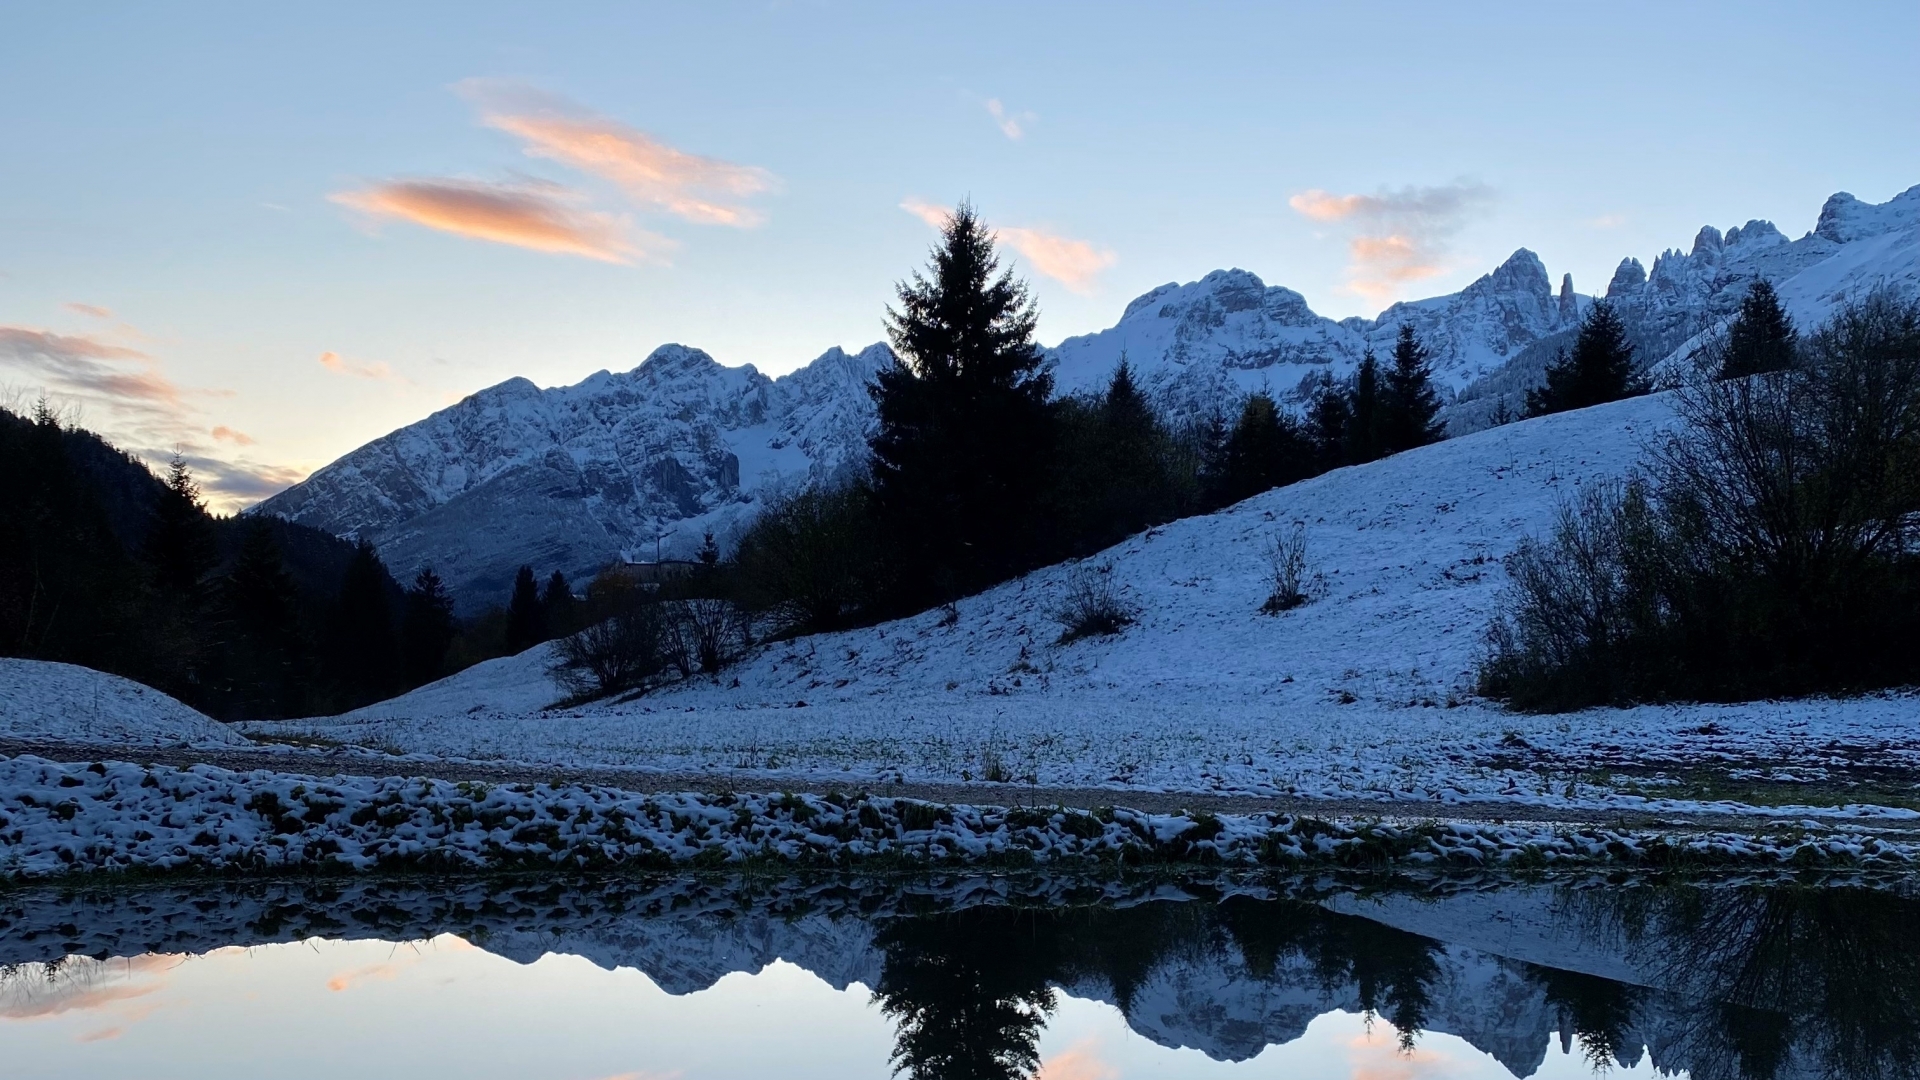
[328,179,652,263]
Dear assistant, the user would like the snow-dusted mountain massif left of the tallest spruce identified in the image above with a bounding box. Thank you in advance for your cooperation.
[257,344,893,605]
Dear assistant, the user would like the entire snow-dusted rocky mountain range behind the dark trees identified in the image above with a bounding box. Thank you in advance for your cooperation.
[252,186,1920,609]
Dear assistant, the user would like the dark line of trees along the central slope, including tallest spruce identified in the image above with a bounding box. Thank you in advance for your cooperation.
[728,206,1444,632]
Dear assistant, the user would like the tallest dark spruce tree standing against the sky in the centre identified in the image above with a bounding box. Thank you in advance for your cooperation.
[870,204,1054,607]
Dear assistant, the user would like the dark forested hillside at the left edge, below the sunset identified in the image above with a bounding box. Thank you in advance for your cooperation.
[0,400,459,719]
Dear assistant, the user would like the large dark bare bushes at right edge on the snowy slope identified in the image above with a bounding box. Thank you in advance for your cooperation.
[1482,294,1920,709]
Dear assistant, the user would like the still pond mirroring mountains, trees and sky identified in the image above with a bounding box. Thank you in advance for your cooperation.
[0,878,1920,1080]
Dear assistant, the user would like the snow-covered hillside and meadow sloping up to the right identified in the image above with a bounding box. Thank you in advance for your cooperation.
[250,396,1920,807]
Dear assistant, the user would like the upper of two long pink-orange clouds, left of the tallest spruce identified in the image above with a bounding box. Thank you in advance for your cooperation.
[457,79,778,227]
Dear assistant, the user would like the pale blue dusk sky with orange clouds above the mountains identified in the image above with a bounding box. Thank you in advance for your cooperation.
[0,0,1920,509]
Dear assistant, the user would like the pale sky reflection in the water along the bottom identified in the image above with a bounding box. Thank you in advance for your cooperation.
[0,934,1655,1080]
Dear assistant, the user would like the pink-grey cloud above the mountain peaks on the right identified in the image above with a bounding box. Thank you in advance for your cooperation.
[1286,183,1494,304]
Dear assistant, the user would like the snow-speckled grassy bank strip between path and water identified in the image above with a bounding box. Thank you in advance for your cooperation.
[0,757,1920,880]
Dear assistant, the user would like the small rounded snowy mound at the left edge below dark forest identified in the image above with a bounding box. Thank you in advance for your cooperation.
[0,659,252,746]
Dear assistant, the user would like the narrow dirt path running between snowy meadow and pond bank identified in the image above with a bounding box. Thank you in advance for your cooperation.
[0,738,1920,836]
